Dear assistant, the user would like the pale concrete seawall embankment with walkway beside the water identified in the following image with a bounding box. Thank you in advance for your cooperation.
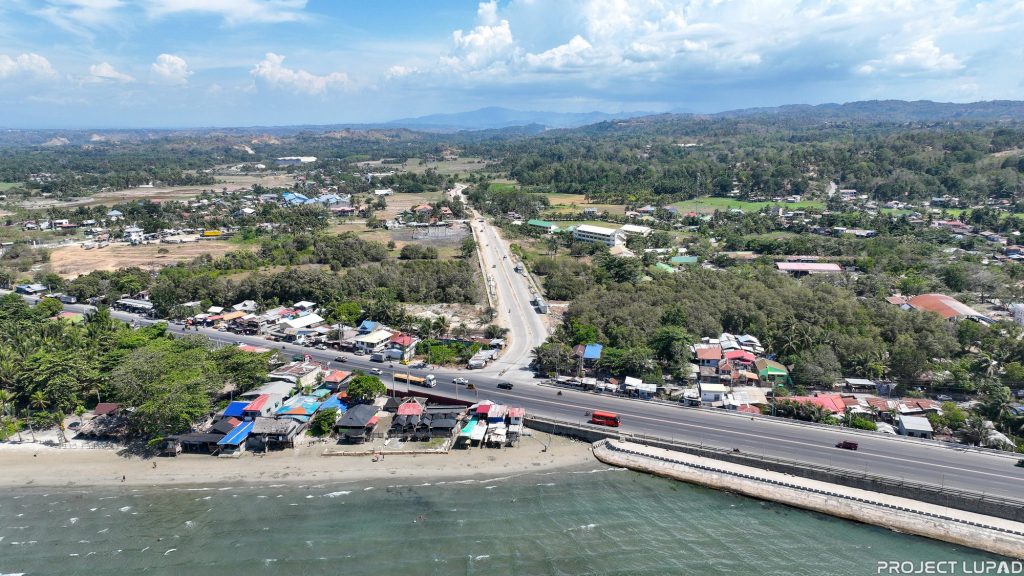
[594,439,1024,559]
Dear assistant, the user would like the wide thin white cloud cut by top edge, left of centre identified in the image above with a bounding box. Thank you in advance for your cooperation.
[146,0,306,26]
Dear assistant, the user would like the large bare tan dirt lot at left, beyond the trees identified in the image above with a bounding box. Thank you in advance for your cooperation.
[50,236,246,278]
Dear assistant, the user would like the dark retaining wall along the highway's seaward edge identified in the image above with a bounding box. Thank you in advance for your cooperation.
[526,416,1024,522]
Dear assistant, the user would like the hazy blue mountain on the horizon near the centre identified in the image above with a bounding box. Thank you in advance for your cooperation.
[386,107,648,132]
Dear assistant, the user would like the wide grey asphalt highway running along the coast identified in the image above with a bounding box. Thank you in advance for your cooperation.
[34,305,1007,498]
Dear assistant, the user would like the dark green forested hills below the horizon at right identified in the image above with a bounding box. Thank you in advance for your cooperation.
[479,115,1024,202]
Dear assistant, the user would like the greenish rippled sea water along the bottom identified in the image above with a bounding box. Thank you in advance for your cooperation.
[0,466,1005,576]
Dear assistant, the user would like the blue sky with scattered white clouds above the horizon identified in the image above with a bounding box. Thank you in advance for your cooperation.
[0,0,1024,128]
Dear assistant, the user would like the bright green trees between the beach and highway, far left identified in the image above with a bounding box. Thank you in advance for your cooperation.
[0,294,269,440]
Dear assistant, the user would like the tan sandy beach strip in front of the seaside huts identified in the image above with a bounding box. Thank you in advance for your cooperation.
[0,433,603,488]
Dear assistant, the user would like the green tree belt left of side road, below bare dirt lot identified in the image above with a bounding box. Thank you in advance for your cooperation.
[59,233,477,317]
